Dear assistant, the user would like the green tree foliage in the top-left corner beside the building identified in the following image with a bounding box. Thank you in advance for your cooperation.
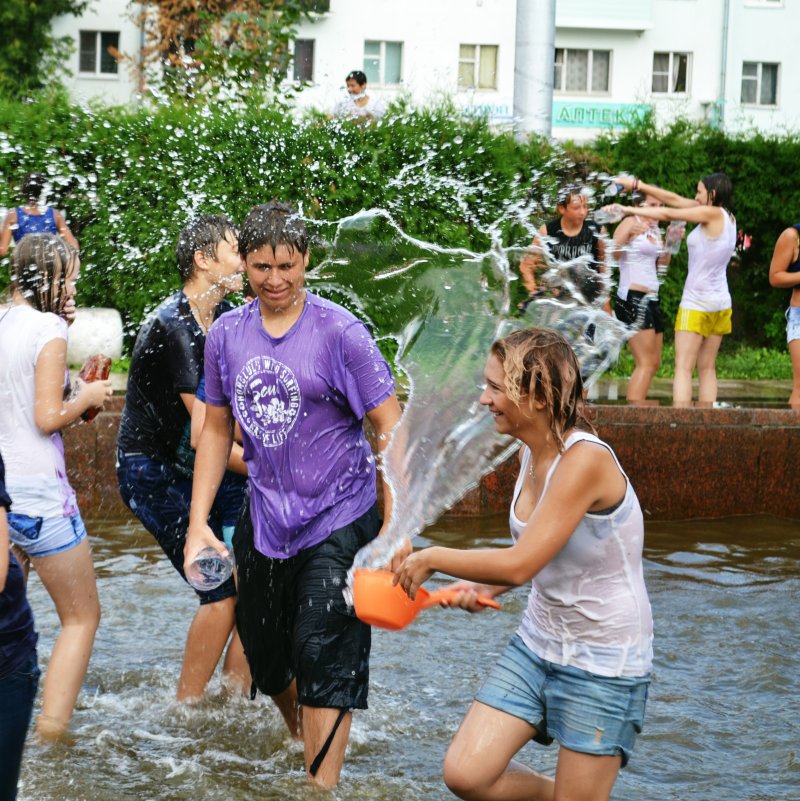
[0,0,88,98]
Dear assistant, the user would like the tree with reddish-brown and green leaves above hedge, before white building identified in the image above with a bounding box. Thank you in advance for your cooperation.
[128,0,313,99]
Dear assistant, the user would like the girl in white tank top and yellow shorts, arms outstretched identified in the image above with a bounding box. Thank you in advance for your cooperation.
[614,172,736,406]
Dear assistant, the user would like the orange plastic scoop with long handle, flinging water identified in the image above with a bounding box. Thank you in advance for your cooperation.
[353,568,500,631]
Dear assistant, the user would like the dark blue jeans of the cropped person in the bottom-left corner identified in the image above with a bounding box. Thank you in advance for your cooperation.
[0,651,39,801]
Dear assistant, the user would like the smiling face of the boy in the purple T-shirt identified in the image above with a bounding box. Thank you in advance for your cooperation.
[245,245,308,315]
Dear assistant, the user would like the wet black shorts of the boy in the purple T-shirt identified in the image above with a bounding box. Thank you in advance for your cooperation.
[234,504,381,709]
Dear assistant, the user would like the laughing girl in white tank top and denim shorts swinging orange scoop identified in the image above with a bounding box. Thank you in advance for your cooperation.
[396,329,652,801]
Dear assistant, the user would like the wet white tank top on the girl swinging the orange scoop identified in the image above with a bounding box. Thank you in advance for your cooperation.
[510,431,653,677]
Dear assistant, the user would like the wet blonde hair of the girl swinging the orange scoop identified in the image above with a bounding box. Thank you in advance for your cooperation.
[491,328,594,452]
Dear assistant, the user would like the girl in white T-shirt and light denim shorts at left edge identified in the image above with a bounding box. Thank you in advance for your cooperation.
[0,234,112,739]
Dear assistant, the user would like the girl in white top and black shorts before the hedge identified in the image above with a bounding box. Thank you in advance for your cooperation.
[614,195,670,403]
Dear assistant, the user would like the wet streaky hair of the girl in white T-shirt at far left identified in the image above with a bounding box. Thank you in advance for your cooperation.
[11,234,78,316]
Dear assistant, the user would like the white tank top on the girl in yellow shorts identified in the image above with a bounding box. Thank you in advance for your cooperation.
[680,209,736,312]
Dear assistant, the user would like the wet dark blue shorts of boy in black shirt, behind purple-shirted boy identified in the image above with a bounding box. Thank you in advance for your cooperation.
[117,453,236,604]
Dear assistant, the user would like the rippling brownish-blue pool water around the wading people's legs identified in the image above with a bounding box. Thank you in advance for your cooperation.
[20,517,800,801]
